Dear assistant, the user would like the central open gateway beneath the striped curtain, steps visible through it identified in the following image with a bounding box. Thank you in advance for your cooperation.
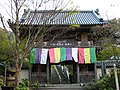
[50,61,77,84]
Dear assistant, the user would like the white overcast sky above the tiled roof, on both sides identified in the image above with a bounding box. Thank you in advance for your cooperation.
[0,0,120,27]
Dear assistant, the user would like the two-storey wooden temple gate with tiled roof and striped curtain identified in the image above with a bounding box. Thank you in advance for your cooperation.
[9,10,107,84]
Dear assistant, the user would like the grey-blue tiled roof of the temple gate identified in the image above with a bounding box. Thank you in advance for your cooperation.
[20,10,107,25]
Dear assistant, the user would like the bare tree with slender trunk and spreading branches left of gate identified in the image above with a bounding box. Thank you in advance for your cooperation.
[1,0,77,85]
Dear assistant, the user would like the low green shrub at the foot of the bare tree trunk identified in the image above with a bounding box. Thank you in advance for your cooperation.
[16,79,30,90]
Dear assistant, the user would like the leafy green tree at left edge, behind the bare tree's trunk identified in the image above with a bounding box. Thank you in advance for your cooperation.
[0,28,15,74]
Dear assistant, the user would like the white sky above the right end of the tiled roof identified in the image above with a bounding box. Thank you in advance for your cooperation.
[74,0,120,20]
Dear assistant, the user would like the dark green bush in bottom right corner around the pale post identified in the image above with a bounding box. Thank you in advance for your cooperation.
[96,68,120,90]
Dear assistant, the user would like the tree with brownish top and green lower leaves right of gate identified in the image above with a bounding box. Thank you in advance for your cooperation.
[92,19,120,60]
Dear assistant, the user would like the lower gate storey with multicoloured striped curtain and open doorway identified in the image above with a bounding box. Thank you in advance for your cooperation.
[30,48,96,84]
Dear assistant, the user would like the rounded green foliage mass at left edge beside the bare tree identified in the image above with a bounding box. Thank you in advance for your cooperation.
[0,29,14,62]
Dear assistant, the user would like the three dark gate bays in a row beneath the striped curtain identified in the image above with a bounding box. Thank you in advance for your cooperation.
[31,61,95,84]
